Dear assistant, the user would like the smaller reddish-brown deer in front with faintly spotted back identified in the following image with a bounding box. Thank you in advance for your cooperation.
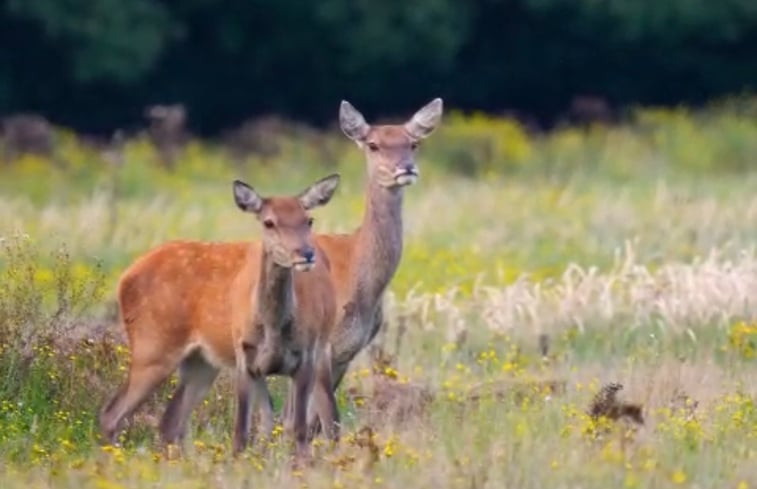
[100,174,339,454]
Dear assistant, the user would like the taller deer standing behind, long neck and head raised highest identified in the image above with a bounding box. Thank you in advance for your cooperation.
[278,98,443,425]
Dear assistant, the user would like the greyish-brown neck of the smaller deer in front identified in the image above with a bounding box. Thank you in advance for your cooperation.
[256,250,294,333]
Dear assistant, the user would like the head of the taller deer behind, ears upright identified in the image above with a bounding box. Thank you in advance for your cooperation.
[339,98,443,188]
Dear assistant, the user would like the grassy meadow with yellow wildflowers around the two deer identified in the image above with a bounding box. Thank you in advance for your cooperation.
[0,98,757,489]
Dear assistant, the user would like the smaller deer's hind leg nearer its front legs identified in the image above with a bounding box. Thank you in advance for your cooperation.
[160,350,218,445]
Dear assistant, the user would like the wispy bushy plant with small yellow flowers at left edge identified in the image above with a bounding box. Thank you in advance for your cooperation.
[0,236,112,458]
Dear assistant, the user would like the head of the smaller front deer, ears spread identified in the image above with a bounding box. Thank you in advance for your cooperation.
[234,174,339,271]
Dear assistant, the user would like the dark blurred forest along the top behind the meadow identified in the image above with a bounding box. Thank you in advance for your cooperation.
[0,0,757,134]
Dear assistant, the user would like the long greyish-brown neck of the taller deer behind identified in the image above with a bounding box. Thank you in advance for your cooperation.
[352,181,403,317]
